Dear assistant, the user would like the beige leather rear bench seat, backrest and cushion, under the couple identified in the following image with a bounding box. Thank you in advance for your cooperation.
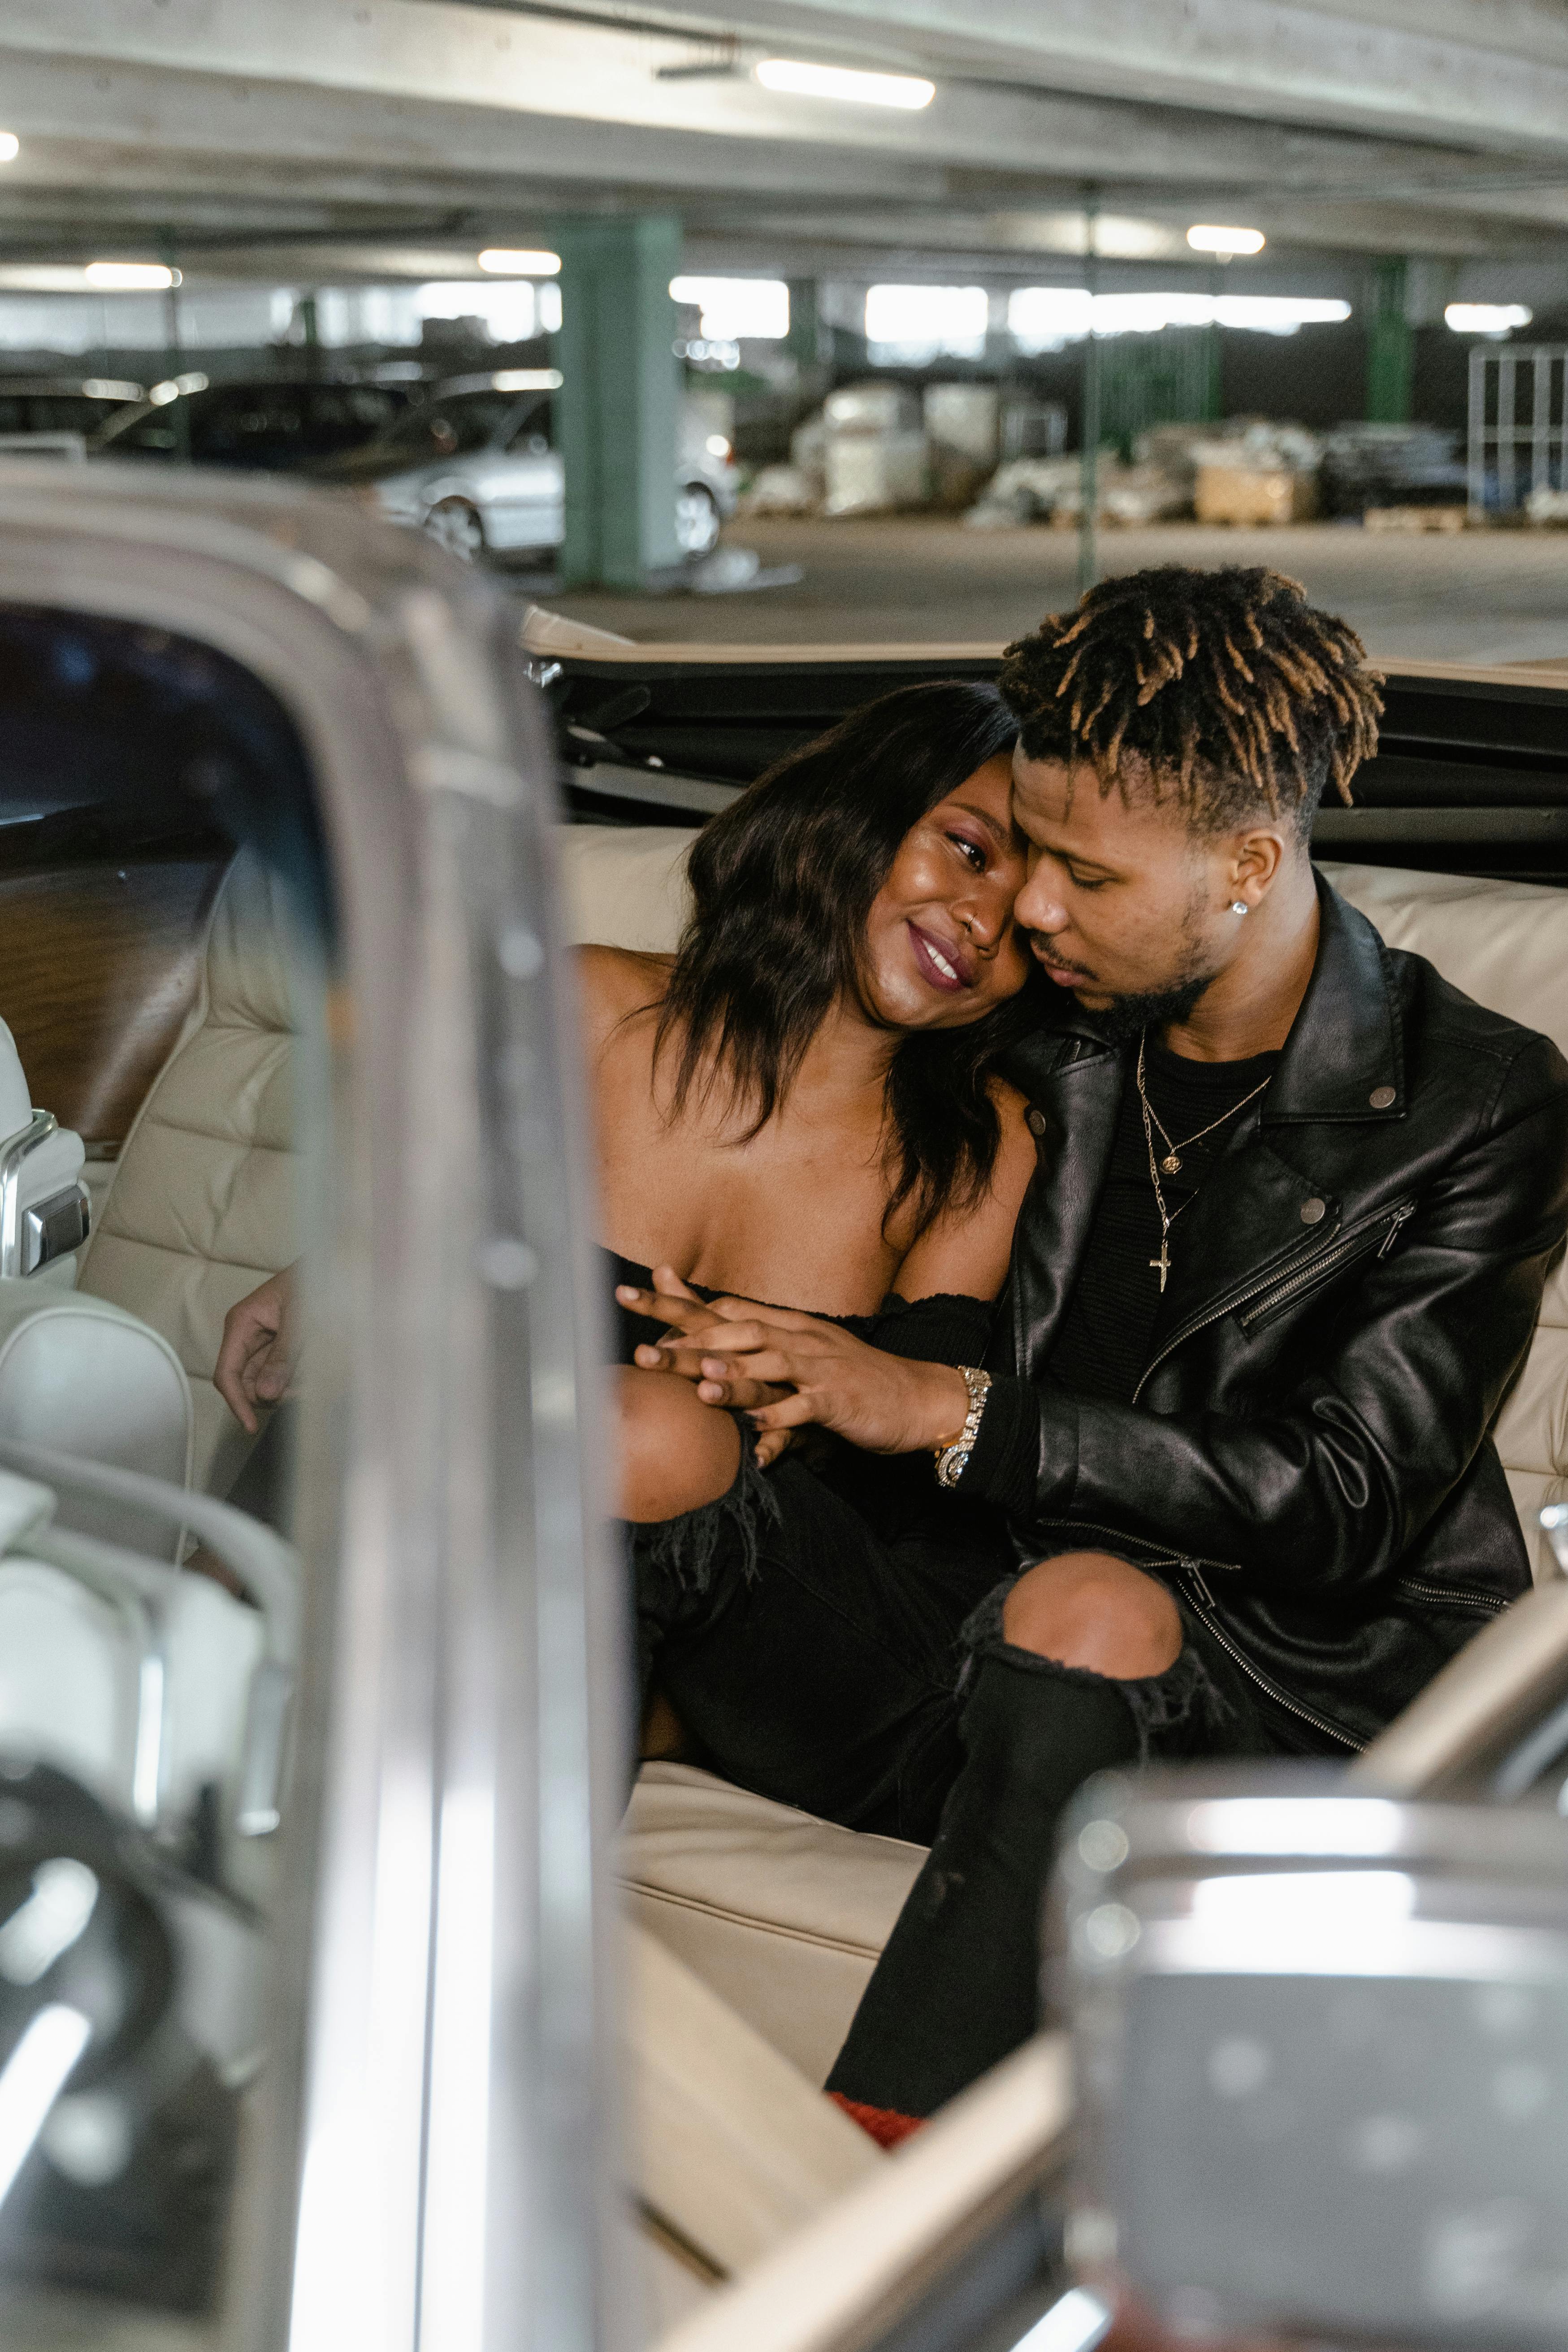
[559,826,1568,2082]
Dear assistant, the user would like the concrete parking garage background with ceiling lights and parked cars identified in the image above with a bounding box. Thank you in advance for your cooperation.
[0,0,1568,663]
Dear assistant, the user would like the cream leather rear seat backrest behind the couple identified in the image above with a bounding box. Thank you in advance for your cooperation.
[559,826,1568,1576]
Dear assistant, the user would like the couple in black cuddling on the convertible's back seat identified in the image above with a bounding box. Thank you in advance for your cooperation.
[585,567,1568,2135]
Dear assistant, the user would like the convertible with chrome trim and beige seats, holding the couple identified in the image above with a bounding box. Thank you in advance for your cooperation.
[0,463,1568,2352]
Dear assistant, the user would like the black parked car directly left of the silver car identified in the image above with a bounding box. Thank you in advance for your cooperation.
[92,369,416,473]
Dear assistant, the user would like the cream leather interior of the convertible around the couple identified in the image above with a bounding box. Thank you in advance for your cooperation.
[0,555,1568,2352]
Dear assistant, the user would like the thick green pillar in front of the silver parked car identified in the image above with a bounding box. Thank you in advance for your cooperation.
[550,214,682,588]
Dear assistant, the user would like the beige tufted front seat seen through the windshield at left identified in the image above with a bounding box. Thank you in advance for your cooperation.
[78,854,296,1494]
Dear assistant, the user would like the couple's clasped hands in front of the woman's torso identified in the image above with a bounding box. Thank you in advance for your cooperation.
[616,1265,969,1465]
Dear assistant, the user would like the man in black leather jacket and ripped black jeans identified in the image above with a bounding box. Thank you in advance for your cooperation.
[625,567,1568,2133]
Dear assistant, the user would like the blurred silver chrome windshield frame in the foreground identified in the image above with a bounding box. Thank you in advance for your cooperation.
[0,461,625,2352]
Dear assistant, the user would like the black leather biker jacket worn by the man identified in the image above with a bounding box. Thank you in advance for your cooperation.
[964,877,1568,1754]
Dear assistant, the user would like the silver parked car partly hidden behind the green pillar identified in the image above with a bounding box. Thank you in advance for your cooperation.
[322,367,738,560]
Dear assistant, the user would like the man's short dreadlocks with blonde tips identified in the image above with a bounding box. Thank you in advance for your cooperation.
[997,564,1382,837]
